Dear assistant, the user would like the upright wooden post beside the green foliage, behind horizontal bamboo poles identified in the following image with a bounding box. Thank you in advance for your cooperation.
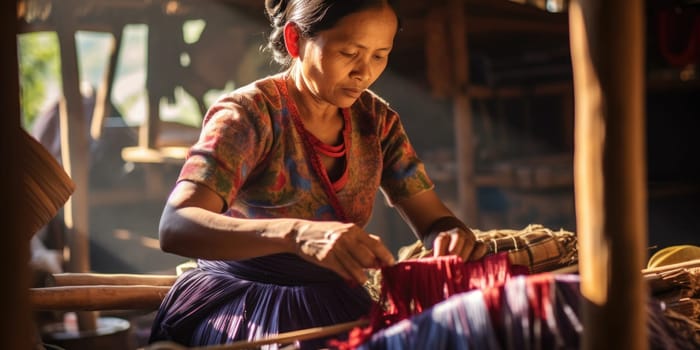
[55,6,97,330]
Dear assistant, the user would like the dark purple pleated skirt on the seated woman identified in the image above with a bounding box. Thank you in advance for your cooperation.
[150,254,372,348]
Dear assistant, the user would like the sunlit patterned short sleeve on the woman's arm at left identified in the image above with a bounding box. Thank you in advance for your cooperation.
[178,96,271,206]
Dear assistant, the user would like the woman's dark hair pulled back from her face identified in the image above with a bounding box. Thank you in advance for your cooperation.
[265,0,396,67]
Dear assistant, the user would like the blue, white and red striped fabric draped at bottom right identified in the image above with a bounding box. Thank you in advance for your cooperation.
[355,273,699,350]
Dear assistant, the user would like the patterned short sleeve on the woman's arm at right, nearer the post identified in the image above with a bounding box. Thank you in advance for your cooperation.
[379,108,434,204]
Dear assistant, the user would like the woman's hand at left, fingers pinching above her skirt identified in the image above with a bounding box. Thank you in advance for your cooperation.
[295,221,395,284]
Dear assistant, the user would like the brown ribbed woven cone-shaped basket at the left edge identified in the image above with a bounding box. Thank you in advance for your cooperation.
[19,130,75,238]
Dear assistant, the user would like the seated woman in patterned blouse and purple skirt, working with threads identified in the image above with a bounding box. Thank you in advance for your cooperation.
[151,0,485,347]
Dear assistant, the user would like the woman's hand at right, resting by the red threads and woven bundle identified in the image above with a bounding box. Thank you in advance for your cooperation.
[433,228,487,261]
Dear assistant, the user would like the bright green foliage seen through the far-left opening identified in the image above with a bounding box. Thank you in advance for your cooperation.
[17,33,61,128]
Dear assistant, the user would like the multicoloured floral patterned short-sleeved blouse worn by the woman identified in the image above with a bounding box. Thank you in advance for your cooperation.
[178,75,433,227]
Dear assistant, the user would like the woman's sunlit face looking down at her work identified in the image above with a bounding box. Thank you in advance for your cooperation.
[298,6,398,108]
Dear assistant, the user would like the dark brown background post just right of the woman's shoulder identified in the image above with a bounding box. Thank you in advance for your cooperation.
[447,0,479,227]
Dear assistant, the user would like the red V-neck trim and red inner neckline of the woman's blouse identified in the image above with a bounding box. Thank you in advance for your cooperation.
[277,80,352,222]
